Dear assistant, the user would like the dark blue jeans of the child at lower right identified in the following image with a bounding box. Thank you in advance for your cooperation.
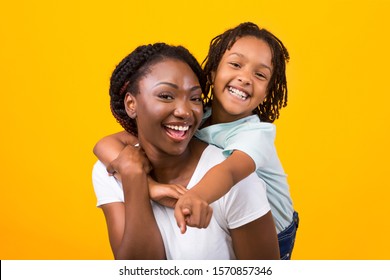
[278,212,299,260]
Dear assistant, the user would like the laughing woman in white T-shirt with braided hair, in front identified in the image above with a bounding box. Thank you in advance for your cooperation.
[93,43,279,259]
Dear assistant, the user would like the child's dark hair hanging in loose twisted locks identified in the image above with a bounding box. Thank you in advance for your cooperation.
[202,22,290,123]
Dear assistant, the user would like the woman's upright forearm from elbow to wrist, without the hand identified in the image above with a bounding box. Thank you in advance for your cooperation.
[115,171,165,260]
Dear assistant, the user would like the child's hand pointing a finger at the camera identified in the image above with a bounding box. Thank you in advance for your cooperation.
[175,191,213,233]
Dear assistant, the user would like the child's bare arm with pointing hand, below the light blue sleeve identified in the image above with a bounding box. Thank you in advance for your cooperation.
[175,150,256,233]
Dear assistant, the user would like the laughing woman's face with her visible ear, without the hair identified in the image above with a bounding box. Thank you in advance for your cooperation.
[125,59,203,157]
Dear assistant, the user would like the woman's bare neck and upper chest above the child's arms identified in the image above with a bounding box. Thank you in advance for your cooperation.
[148,139,207,186]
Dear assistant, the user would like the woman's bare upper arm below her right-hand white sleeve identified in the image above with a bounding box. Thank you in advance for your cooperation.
[230,211,280,260]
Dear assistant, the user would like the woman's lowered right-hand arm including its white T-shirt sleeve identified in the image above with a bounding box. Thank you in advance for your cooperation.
[227,171,279,259]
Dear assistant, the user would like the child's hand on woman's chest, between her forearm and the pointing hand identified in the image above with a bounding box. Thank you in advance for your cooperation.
[149,179,187,208]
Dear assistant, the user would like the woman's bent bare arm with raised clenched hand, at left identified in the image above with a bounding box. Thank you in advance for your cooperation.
[102,146,165,259]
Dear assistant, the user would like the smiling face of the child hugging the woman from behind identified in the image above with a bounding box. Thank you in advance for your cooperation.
[212,36,273,122]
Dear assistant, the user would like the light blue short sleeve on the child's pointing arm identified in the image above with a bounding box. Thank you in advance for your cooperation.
[223,122,276,169]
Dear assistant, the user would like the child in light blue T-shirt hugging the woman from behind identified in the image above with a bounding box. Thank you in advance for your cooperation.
[95,23,298,259]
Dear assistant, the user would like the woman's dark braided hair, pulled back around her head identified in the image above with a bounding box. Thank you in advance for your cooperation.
[109,43,206,136]
